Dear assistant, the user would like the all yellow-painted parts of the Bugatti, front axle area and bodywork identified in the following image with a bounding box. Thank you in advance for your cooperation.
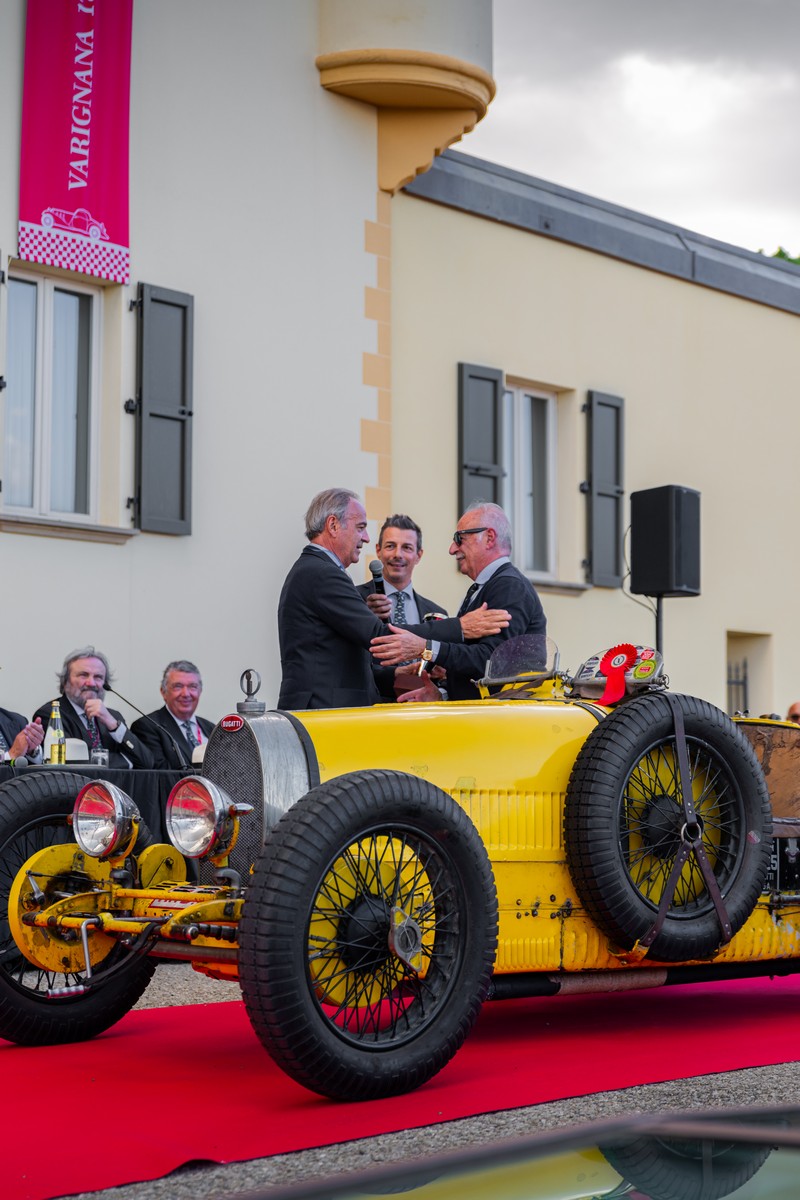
[10,680,800,986]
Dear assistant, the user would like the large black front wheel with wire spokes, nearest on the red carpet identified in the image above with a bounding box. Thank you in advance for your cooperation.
[239,770,498,1100]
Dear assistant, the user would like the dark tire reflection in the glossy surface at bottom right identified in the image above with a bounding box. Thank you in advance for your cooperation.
[600,1132,772,1200]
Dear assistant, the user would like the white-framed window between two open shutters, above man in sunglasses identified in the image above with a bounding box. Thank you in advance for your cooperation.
[503,385,557,576]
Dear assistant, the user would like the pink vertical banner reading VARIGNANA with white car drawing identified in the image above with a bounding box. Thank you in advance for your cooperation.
[19,0,133,283]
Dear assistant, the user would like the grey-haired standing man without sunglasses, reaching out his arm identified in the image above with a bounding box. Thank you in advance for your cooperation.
[278,487,509,709]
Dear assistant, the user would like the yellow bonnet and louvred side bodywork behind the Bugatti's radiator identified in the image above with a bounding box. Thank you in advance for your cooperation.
[289,683,800,974]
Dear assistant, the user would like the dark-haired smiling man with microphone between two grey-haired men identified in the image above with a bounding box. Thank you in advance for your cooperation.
[356,512,446,700]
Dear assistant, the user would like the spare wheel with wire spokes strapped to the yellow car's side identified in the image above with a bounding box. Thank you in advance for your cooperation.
[564,694,772,962]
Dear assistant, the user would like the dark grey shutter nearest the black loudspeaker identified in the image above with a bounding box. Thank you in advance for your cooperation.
[584,391,625,588]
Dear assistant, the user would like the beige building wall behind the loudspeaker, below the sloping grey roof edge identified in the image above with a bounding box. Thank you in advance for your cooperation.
[392,194,800,712]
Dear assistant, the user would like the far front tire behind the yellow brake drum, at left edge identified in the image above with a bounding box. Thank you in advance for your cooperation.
[0,770,155,1045]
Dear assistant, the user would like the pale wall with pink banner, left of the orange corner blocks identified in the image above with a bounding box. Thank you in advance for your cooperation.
[0,0,491,718]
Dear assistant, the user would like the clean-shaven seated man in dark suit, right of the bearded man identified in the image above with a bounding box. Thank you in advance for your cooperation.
[132,659,213,770]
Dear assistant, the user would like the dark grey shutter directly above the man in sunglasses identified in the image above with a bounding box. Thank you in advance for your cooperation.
[458,362,505,514]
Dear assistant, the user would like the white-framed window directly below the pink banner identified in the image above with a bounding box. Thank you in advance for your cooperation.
[2,274,102,521]
